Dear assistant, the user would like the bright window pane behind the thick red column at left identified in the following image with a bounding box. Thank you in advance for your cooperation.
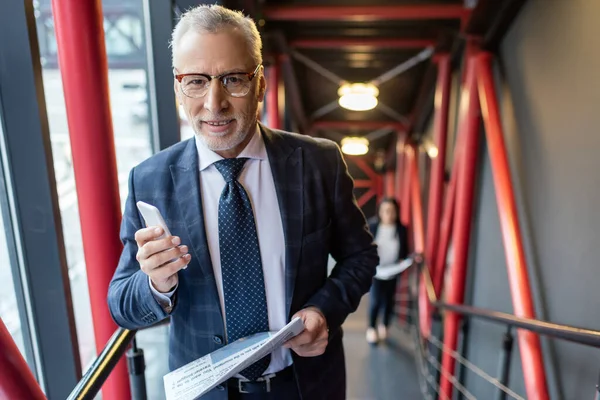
[35,0,152,370]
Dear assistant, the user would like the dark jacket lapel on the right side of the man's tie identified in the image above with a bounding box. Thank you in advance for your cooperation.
[260,125,304,317]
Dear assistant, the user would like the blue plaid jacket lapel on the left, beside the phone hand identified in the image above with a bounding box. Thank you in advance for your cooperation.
[170,138,221,310]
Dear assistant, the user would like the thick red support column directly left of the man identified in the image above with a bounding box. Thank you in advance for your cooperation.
[52,0,131,400]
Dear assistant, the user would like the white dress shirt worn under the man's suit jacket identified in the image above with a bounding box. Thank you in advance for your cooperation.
[150,128,292,374]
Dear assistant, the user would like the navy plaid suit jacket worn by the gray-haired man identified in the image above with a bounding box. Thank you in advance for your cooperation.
[108,125,378,400]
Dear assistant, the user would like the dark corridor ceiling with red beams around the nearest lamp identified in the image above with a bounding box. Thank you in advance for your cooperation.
[226,0,524,154]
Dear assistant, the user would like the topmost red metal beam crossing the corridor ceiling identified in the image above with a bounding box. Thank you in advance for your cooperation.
[263,4,469,21]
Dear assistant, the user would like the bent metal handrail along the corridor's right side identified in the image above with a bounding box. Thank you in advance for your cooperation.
[420,263,600,348]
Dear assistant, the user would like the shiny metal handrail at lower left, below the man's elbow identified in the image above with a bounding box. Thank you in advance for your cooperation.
[67,328,137,400]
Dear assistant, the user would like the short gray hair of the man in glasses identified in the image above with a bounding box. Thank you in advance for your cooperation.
[171,4,262,66]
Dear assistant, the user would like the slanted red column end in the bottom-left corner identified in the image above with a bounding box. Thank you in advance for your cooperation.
[0,318,46,400]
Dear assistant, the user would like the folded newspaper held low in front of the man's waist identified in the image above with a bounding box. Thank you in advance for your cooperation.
[163,318,304,400]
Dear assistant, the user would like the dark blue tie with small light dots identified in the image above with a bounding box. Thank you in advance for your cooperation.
[214,158,271,380]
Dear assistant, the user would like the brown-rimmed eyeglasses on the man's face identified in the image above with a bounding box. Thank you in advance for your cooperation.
[175,64,262,99]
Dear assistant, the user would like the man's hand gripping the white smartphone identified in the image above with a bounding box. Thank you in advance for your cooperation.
[135,226,191,293]
